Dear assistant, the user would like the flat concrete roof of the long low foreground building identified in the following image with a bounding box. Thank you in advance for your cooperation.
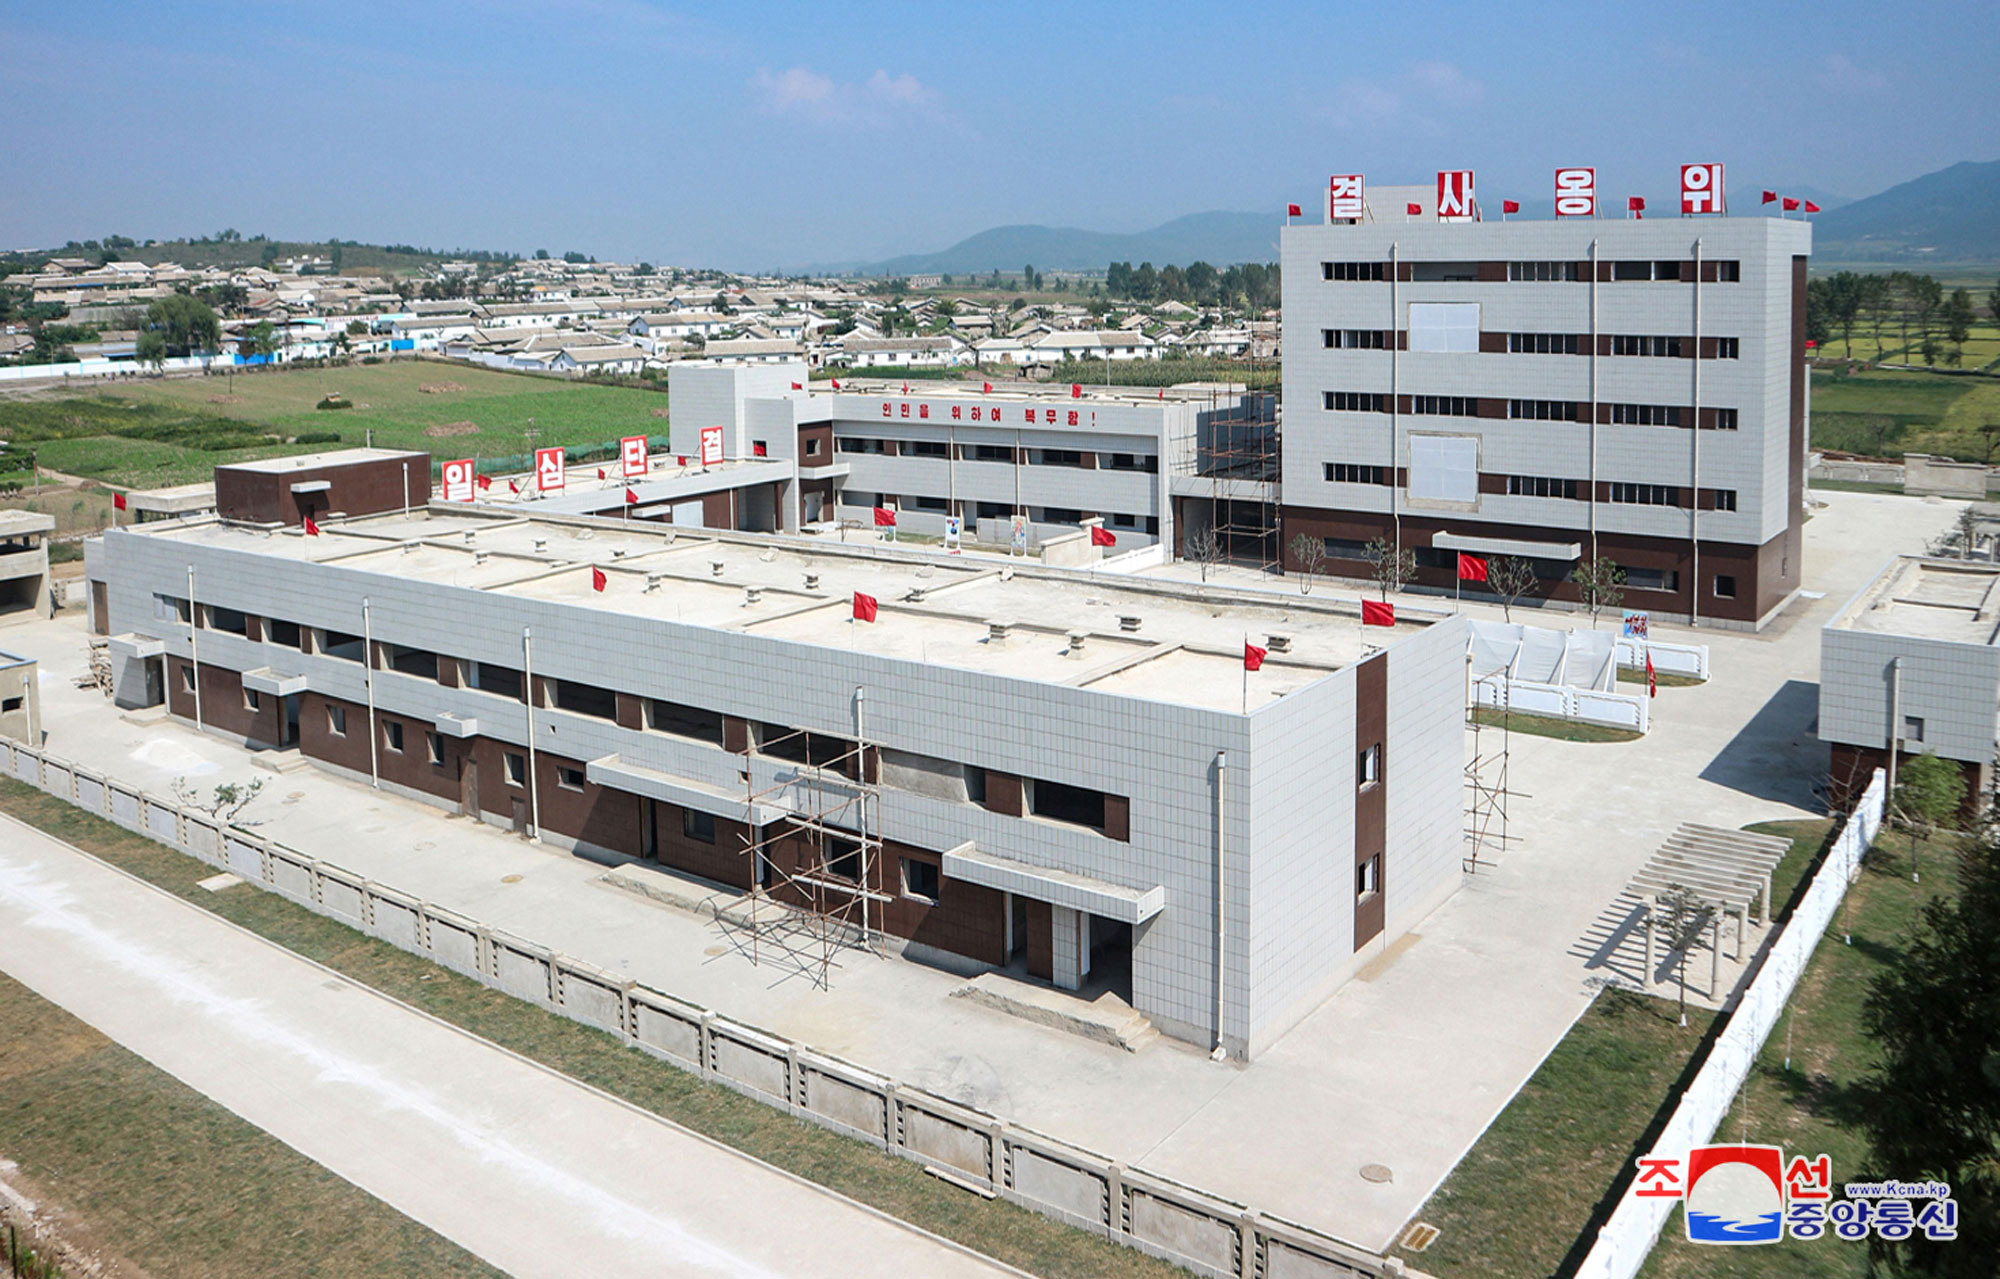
[118,504,1430,711]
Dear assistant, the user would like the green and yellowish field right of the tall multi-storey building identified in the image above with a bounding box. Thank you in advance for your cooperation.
[1812,370,2000,462]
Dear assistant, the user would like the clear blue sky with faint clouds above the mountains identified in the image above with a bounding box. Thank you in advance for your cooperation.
[0,0,2000,268]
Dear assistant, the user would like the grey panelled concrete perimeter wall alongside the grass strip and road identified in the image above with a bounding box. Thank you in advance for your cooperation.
[0,739,1398,1279]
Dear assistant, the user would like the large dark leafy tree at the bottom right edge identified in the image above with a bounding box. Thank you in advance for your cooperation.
[1854,807,2000,1279]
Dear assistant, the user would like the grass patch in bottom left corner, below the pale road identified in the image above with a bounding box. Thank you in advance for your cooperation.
[0,975,500,1279]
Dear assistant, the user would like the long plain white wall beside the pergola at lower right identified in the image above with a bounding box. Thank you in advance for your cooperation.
[1576,769,1886,1279]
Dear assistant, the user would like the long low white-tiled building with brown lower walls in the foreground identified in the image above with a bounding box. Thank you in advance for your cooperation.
[86,499,1466,1057]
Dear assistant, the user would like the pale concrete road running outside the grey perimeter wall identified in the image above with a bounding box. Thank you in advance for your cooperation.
[0,817,1020,1277]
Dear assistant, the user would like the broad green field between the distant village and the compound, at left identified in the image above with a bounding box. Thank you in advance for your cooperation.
[0,360,666,488]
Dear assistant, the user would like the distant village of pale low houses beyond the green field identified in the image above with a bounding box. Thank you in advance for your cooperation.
[0,254,1278,378]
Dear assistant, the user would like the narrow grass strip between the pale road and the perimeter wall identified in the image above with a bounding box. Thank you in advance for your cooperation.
[0,779,1186,1279]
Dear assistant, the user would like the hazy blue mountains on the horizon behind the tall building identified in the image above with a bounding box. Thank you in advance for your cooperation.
[852,160,2000,276]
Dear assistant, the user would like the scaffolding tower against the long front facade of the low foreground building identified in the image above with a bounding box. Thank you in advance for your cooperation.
[718,711,894,989]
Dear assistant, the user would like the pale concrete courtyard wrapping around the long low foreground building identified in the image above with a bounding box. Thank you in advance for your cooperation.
[0,494,1956,1249]
